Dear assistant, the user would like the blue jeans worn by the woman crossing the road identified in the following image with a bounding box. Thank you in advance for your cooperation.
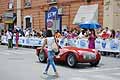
[45,51,56,72]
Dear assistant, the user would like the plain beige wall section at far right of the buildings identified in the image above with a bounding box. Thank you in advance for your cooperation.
[103,0,120,30]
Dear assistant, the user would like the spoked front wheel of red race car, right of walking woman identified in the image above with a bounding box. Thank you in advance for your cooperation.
[66,53,77,67]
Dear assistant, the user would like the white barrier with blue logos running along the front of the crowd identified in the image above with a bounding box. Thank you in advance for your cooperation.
[1,36,120,52]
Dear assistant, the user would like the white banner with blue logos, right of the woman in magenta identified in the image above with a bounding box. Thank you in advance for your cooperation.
[95,39,120,52]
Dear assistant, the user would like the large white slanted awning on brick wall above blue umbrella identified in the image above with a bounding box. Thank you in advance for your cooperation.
[73,4,98,24]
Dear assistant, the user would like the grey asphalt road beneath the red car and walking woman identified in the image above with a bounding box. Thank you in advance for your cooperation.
[0,45,120,80]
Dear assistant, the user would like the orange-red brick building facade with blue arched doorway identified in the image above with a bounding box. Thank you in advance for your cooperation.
[0,0,104,31]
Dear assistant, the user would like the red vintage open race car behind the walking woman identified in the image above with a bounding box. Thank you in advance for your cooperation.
[36,46,101,67]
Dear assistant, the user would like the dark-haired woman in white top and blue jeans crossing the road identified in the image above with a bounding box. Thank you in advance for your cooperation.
[40,30,58,77]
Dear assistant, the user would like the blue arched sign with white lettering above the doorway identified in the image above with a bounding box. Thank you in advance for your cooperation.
[47,7,58,19]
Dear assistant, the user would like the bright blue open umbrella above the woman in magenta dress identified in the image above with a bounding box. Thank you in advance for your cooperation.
[79,21,101,29]
